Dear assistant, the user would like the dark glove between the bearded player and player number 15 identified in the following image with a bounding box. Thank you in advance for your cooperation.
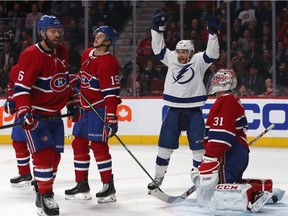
[67,94,84,122]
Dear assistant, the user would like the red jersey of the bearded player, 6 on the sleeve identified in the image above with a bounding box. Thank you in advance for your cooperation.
[13,43,71,116]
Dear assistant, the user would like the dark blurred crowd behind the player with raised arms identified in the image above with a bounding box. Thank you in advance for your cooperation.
[129,1,288,97]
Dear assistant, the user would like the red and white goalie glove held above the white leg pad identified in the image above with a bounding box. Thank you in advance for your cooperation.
[198,155,220,189]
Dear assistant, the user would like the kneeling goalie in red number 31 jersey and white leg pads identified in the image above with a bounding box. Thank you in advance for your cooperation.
[193,69,284,212]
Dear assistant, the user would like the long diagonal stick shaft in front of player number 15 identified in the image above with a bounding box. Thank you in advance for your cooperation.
[76,90,163,193]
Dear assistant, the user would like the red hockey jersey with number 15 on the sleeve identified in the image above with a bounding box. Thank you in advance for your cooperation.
[80,48,121,114]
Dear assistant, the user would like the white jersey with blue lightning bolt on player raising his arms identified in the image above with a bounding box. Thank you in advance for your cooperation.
[151,30,219,108]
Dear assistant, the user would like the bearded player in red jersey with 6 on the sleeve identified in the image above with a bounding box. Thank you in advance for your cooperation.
[13,15,80,215]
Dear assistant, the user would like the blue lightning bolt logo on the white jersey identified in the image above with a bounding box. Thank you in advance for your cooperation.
[172,64,195,84]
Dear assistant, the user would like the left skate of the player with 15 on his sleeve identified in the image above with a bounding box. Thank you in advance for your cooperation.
[65,180,92,200]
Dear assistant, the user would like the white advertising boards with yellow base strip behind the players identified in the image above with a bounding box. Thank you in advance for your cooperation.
[0,98,288,147]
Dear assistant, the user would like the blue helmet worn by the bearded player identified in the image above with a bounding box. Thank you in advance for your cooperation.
[37,15,63,36]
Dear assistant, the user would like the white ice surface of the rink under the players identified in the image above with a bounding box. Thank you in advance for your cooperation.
[0,145,288,216]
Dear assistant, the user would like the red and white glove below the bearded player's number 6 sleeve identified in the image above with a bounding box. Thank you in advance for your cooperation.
[17,107,39,130]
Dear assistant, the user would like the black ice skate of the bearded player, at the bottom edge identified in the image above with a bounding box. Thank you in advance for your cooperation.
[36,193,60,216]
